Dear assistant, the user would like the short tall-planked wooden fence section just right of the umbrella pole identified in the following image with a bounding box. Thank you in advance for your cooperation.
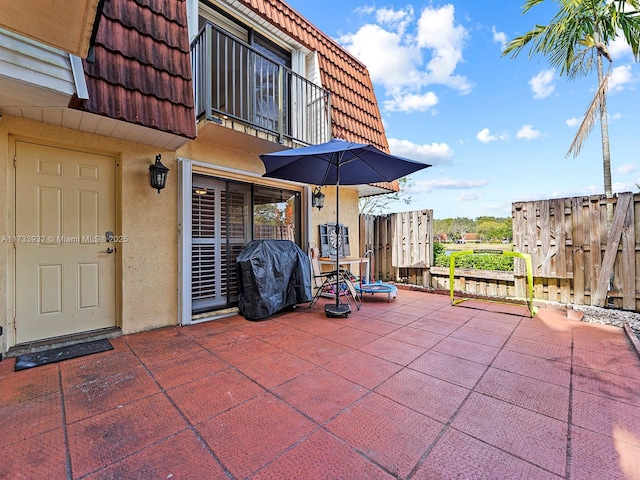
[360,210,433,286]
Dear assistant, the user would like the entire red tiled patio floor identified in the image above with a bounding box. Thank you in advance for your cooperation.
[0,290,640,480]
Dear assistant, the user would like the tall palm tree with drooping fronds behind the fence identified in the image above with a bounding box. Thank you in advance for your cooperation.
[502,0,640,223]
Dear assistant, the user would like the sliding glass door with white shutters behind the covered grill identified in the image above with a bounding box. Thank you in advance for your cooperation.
[191,175,301,314]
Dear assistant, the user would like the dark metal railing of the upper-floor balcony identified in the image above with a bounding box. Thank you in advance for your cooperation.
[191,23,331,145]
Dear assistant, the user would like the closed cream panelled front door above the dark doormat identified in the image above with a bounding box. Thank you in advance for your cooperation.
[13,141,118,344]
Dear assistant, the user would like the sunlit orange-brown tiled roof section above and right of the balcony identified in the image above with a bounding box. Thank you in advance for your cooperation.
[240,0,389,152]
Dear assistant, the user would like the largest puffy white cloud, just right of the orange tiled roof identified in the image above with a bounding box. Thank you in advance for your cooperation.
[339,5,472,112]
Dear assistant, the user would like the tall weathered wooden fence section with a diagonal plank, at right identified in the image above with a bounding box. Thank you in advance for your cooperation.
[512,193,640,311]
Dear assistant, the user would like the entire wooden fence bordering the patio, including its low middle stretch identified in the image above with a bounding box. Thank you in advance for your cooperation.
[360,193,640,311]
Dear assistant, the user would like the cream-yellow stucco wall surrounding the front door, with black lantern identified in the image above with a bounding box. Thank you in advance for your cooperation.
[0,115,178,351]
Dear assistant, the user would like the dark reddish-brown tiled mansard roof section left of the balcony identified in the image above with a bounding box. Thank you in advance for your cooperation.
[72,0,196,138]
